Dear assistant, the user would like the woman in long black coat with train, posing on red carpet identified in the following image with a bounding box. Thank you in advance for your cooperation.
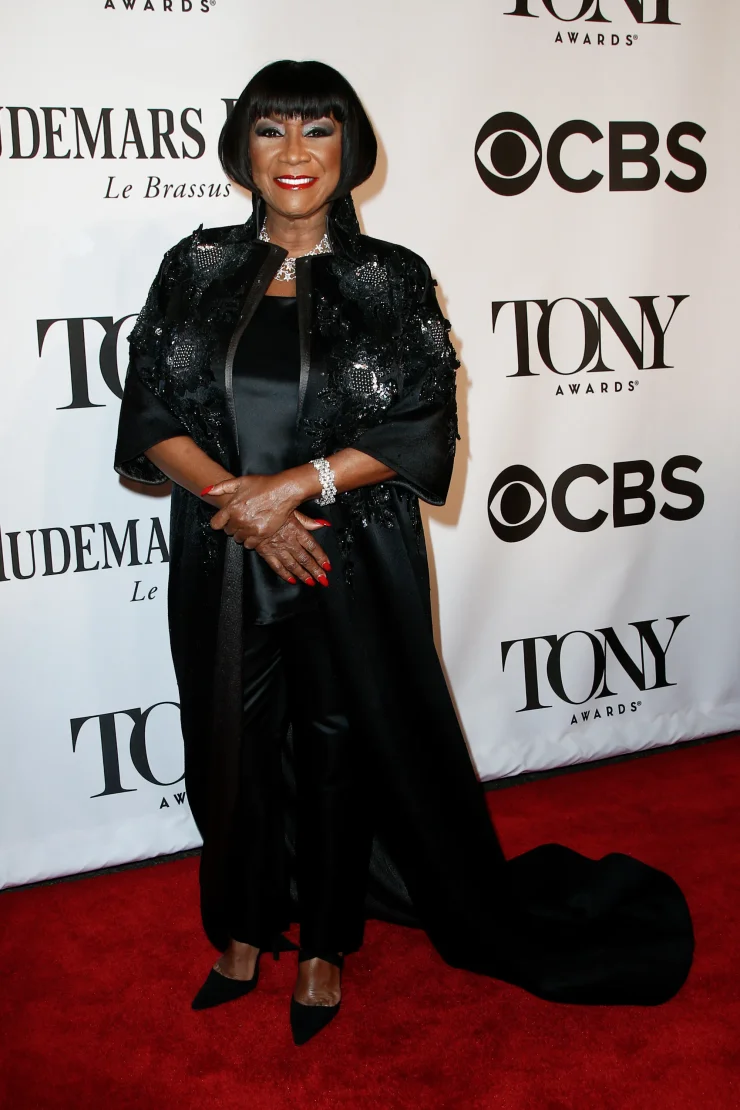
[115,61,692,1043]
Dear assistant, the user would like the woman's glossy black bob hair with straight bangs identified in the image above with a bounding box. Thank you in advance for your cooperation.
[219,60,377,198]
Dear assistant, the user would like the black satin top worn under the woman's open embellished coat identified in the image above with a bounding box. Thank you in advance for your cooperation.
[233,296,320,624]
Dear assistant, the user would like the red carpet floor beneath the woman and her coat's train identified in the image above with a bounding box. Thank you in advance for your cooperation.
[0,738,740,1110]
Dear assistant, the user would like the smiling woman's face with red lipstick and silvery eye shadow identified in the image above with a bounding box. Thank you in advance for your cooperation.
[250,115,342,219]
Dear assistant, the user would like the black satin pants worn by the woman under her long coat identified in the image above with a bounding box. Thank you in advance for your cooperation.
[229,608,372,951]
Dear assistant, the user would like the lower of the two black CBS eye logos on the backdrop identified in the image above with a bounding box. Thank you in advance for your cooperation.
[488,455,704,544]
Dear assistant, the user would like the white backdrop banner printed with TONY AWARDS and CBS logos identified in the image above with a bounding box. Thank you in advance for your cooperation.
[0,0,740,885]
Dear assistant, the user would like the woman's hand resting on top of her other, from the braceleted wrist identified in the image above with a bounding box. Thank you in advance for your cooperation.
[209,472,306,549]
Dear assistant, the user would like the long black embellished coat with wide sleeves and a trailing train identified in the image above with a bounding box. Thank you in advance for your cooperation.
[115,198,692,1005]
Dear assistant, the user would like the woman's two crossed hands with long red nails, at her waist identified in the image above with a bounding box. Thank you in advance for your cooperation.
[203,471,332,586]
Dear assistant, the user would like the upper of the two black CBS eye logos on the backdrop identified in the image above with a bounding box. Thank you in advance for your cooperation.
[475,112,707,196]
